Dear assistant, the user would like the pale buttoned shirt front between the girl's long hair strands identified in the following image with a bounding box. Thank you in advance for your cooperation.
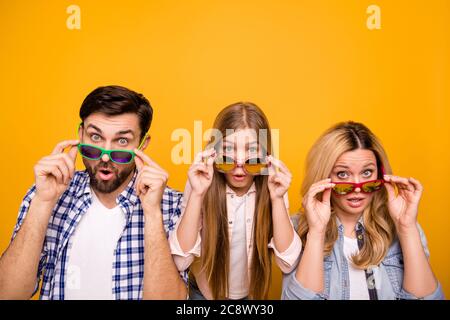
[228,196,249,299]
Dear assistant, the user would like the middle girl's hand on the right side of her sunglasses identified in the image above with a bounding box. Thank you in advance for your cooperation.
[266,156,292,200]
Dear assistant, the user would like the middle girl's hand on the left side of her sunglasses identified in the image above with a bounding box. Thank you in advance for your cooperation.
[188,149,216,196]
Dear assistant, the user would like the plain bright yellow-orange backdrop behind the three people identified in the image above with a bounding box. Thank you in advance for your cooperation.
[0,0,450,299]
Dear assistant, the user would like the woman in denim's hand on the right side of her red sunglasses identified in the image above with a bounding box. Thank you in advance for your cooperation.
[384,175,423,232]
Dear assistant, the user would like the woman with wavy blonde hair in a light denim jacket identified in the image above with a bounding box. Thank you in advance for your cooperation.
[283,122,443,300]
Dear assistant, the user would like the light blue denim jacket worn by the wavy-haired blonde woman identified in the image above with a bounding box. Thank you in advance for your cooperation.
[282,215,444,300]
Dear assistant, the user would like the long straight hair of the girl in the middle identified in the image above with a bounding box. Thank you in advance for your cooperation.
[201,102,272,299]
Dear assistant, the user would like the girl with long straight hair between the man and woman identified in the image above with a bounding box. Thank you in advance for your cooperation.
[169,102,301,299]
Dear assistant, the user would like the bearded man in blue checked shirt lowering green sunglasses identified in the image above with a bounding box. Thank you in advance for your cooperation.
[0,86,187,299]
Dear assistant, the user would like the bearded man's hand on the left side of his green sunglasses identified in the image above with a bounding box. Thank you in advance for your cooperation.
[34,140,79,202]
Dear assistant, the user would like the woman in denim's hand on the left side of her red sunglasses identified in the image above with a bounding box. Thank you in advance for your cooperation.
[302,179,335,234]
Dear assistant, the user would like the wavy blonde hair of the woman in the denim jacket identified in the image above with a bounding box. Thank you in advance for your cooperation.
[298,121,395,269]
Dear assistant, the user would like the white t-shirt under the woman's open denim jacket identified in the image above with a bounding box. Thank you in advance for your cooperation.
[344,236,370,300]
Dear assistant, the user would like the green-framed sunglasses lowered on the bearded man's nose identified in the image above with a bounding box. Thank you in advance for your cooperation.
[78,123,148,164]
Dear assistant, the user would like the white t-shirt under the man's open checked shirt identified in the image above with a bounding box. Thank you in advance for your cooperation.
[65,189,126,300]
